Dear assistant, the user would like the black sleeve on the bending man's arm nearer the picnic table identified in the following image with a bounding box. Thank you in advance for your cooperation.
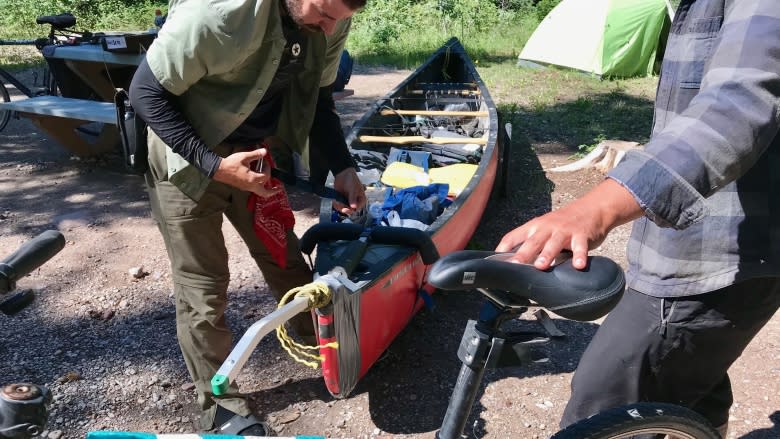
[130,59,222,178]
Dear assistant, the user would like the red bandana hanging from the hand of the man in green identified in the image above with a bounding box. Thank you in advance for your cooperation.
[247,153,295,268]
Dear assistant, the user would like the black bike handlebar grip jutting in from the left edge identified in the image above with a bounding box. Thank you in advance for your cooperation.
[0,230,65,294]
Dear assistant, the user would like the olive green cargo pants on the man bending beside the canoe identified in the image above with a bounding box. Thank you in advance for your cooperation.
[146,141,314,430]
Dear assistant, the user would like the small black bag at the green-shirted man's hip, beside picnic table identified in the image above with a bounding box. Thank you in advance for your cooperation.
[114,88,149,175]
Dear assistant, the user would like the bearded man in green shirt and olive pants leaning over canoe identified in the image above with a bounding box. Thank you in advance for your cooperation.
[130,0,366,436]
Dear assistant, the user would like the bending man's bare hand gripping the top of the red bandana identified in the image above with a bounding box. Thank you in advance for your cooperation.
[214,148,282,197]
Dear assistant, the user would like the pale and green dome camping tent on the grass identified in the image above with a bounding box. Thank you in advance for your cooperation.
[518,0,672,77]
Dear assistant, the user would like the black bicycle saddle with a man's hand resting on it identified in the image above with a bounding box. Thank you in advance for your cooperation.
[428,250,625,321]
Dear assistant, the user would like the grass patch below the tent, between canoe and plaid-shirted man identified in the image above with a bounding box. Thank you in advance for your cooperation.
[477,60,657,153]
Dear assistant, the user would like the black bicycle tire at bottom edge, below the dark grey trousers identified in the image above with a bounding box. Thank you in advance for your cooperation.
[551,402,721,439]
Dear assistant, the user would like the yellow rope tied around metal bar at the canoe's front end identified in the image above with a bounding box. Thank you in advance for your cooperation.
[276,282,339,369]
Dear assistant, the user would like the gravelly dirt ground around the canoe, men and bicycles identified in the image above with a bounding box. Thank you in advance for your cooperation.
[0,68,780,439]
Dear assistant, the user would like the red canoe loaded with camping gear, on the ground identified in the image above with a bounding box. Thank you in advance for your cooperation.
[301,38,509,397]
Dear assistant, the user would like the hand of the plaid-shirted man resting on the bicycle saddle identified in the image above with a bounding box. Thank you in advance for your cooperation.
[496,179,643,270]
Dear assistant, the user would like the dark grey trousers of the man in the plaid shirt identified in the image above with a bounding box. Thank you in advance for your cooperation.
[561,278,780,427]
